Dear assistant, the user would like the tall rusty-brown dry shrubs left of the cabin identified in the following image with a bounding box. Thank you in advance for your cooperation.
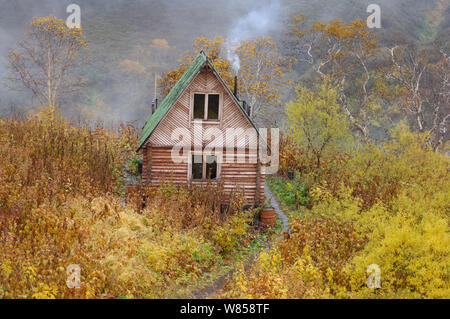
[0,110,137,216]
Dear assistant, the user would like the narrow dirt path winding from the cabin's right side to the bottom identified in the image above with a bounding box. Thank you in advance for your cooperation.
[191,182,289,299]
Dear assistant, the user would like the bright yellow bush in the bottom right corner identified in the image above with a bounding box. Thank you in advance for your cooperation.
[346,215,450,298]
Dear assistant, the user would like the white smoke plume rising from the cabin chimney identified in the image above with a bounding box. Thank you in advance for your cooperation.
[225,0,281,74]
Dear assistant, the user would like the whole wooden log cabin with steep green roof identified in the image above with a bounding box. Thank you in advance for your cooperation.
[138,51,270,205]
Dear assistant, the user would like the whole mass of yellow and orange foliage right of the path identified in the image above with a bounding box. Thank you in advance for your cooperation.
[222,126,450,298]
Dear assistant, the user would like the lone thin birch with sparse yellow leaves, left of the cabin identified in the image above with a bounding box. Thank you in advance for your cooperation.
[9,16,87,113]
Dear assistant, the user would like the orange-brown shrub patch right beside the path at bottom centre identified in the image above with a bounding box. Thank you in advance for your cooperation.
[223,216,366,298]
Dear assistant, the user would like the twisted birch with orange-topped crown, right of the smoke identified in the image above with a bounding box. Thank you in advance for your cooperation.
[291,15,380,141]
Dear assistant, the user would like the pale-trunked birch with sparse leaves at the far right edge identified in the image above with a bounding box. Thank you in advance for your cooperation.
[386,45,450,150]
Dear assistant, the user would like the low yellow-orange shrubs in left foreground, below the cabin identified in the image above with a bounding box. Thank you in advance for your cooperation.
[0,186,251,298]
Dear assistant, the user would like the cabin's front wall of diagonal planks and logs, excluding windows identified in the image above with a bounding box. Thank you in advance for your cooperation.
[143,71,264,204]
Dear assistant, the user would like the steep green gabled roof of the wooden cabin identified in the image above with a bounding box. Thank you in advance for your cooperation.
[137,51,271,153]
